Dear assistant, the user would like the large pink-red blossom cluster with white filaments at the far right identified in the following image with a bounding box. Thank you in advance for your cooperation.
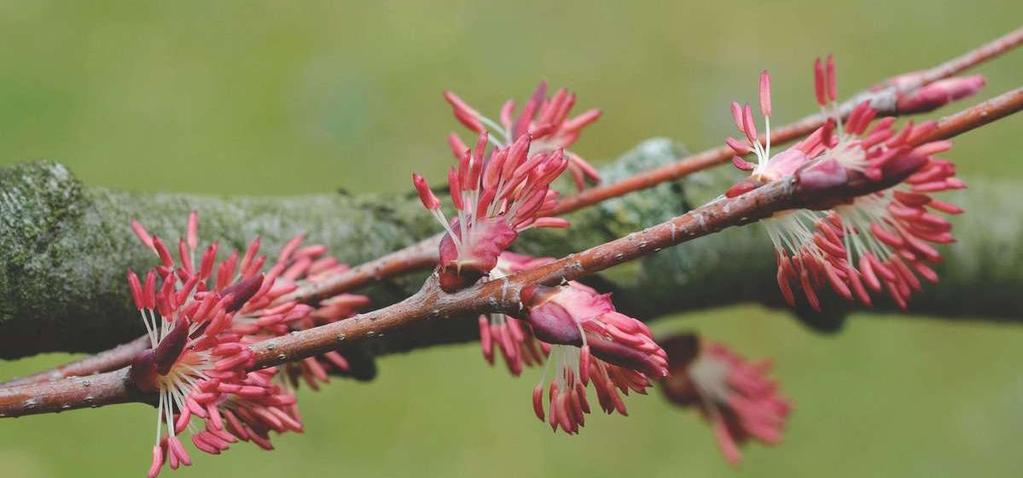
[726,57,983,310]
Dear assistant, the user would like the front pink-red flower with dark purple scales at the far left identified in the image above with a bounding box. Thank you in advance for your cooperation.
[128,257,277,478]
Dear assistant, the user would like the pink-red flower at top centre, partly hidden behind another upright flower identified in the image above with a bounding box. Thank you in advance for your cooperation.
[444,82,601,190]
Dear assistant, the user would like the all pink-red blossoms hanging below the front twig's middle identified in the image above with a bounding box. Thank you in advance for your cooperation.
[479,252,668,434]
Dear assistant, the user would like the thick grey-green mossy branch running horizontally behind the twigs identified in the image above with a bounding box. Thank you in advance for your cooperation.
[0,140,1023,358]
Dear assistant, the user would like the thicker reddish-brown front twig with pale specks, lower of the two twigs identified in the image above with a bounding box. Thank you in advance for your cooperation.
[0,88,1023,417]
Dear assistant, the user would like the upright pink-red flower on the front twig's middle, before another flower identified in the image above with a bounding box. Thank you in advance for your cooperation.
[412,133,568,292]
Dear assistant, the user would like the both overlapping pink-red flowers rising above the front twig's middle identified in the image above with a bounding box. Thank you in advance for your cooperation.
[412,83,601,292]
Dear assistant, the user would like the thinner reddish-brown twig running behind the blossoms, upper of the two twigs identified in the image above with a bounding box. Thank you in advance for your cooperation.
[3,28,1023,385]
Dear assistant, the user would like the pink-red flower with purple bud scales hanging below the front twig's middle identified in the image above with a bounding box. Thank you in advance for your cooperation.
[523,283,667,434]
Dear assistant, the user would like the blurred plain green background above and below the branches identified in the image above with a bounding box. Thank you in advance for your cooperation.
[0,0,1023,478]
